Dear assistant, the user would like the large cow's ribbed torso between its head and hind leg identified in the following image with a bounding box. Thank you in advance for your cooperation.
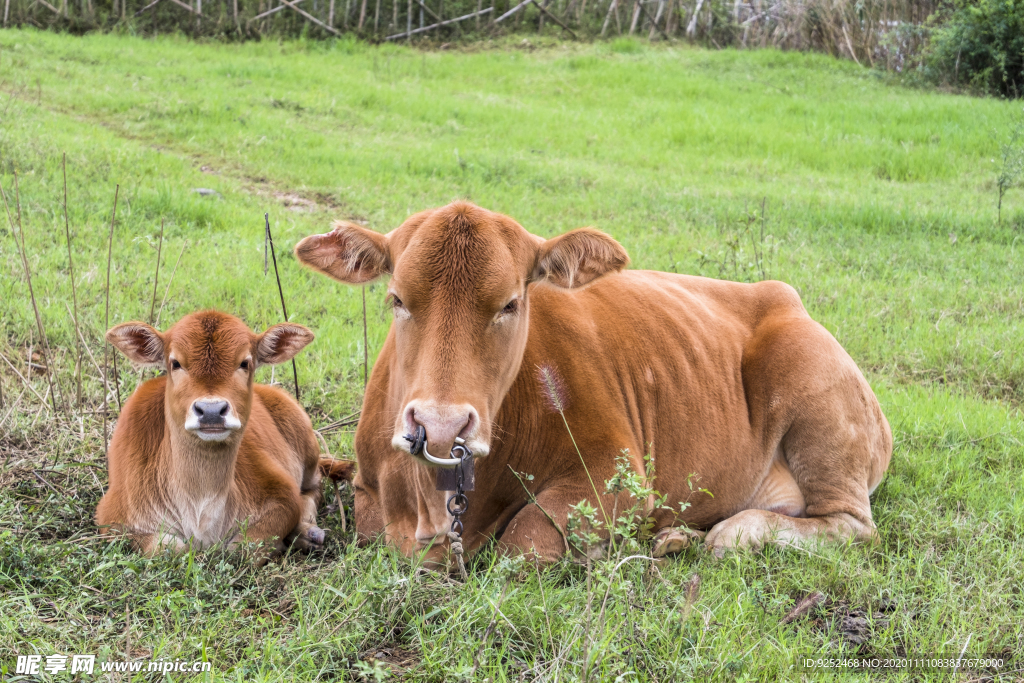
[496,271,852,526]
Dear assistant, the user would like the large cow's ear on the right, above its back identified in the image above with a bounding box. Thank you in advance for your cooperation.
[532,227,630,289]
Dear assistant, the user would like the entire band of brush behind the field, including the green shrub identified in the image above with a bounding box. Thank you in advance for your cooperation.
[12,0,1024,97]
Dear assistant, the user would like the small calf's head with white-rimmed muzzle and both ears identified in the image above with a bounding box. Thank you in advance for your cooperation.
[106,310,313,447]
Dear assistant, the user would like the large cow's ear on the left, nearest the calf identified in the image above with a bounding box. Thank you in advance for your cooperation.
[295,220,391,285]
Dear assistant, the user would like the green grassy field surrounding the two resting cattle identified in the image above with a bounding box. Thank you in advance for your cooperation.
[0,31,1024,682]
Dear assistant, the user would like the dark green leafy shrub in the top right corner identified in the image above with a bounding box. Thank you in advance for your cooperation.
[928,0,1024,97]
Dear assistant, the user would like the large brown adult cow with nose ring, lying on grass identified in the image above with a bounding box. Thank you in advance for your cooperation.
[295,202,892,561]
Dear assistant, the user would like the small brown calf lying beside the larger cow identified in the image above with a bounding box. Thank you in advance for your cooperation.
[96,310,350,554]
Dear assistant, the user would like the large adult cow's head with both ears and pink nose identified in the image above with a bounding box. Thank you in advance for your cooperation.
[295,202,629,458]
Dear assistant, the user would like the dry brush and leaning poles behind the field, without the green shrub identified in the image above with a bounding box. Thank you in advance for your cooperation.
[3,0,945,49]
